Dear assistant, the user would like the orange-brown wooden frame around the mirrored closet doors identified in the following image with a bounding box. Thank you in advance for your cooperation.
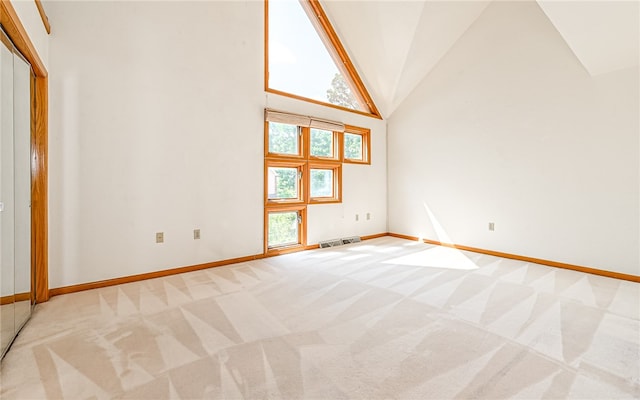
[0,0,49,303]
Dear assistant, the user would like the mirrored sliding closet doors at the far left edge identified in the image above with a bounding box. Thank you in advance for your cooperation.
[0,27,35,357]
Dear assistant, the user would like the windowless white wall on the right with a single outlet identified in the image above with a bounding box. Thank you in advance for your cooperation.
[388,2,640,275]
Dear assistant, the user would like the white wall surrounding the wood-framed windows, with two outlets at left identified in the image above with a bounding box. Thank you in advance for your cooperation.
[47,1,386,288]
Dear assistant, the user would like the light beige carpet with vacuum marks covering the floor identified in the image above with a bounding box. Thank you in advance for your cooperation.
[0,238,640,400]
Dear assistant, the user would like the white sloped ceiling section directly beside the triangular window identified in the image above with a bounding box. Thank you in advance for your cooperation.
[322,0,490,117]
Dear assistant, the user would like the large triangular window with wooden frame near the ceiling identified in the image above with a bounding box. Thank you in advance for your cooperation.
[265,0,380,117]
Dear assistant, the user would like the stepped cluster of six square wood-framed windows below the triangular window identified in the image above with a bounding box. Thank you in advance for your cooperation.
[264,110,370,253]
